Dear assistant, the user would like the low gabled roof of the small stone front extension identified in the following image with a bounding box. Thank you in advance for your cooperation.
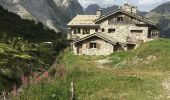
[72,32,118,45]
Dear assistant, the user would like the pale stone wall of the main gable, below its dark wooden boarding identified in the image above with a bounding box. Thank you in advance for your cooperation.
[99,13,149,43]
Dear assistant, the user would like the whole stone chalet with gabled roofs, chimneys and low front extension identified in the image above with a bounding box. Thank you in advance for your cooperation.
[67,3,159,55]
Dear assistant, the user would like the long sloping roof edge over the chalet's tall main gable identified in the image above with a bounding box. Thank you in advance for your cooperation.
[94,9,156,26]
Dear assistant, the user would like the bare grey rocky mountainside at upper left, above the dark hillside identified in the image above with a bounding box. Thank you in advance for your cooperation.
[0,0,83,32]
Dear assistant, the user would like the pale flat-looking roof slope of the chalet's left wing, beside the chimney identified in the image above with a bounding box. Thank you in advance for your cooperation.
[67,15,97,26]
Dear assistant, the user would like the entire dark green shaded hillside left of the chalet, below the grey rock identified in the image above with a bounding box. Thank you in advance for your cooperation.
[0,7,66,92]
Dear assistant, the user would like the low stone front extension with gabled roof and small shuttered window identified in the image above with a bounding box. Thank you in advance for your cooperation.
[71,33,127,55]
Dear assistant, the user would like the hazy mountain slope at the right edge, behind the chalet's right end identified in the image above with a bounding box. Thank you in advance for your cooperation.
[146,2,170,37]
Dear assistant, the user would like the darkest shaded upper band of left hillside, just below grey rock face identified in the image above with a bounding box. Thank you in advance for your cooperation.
[0,7,57,42]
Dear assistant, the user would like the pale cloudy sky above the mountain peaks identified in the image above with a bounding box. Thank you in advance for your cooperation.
[78,0,170,11]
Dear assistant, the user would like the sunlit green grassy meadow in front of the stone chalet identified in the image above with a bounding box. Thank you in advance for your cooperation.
[16,39,170,100]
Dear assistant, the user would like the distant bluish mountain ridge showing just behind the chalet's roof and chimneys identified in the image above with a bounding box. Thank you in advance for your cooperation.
[84,4,147,16]
